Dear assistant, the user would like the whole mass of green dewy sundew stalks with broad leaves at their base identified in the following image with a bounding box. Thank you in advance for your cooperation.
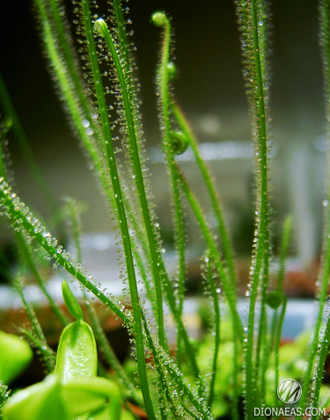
[0,0,330,419]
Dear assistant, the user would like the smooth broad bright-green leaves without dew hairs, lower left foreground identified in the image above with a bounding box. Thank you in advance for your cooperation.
[3,282,121,420]
